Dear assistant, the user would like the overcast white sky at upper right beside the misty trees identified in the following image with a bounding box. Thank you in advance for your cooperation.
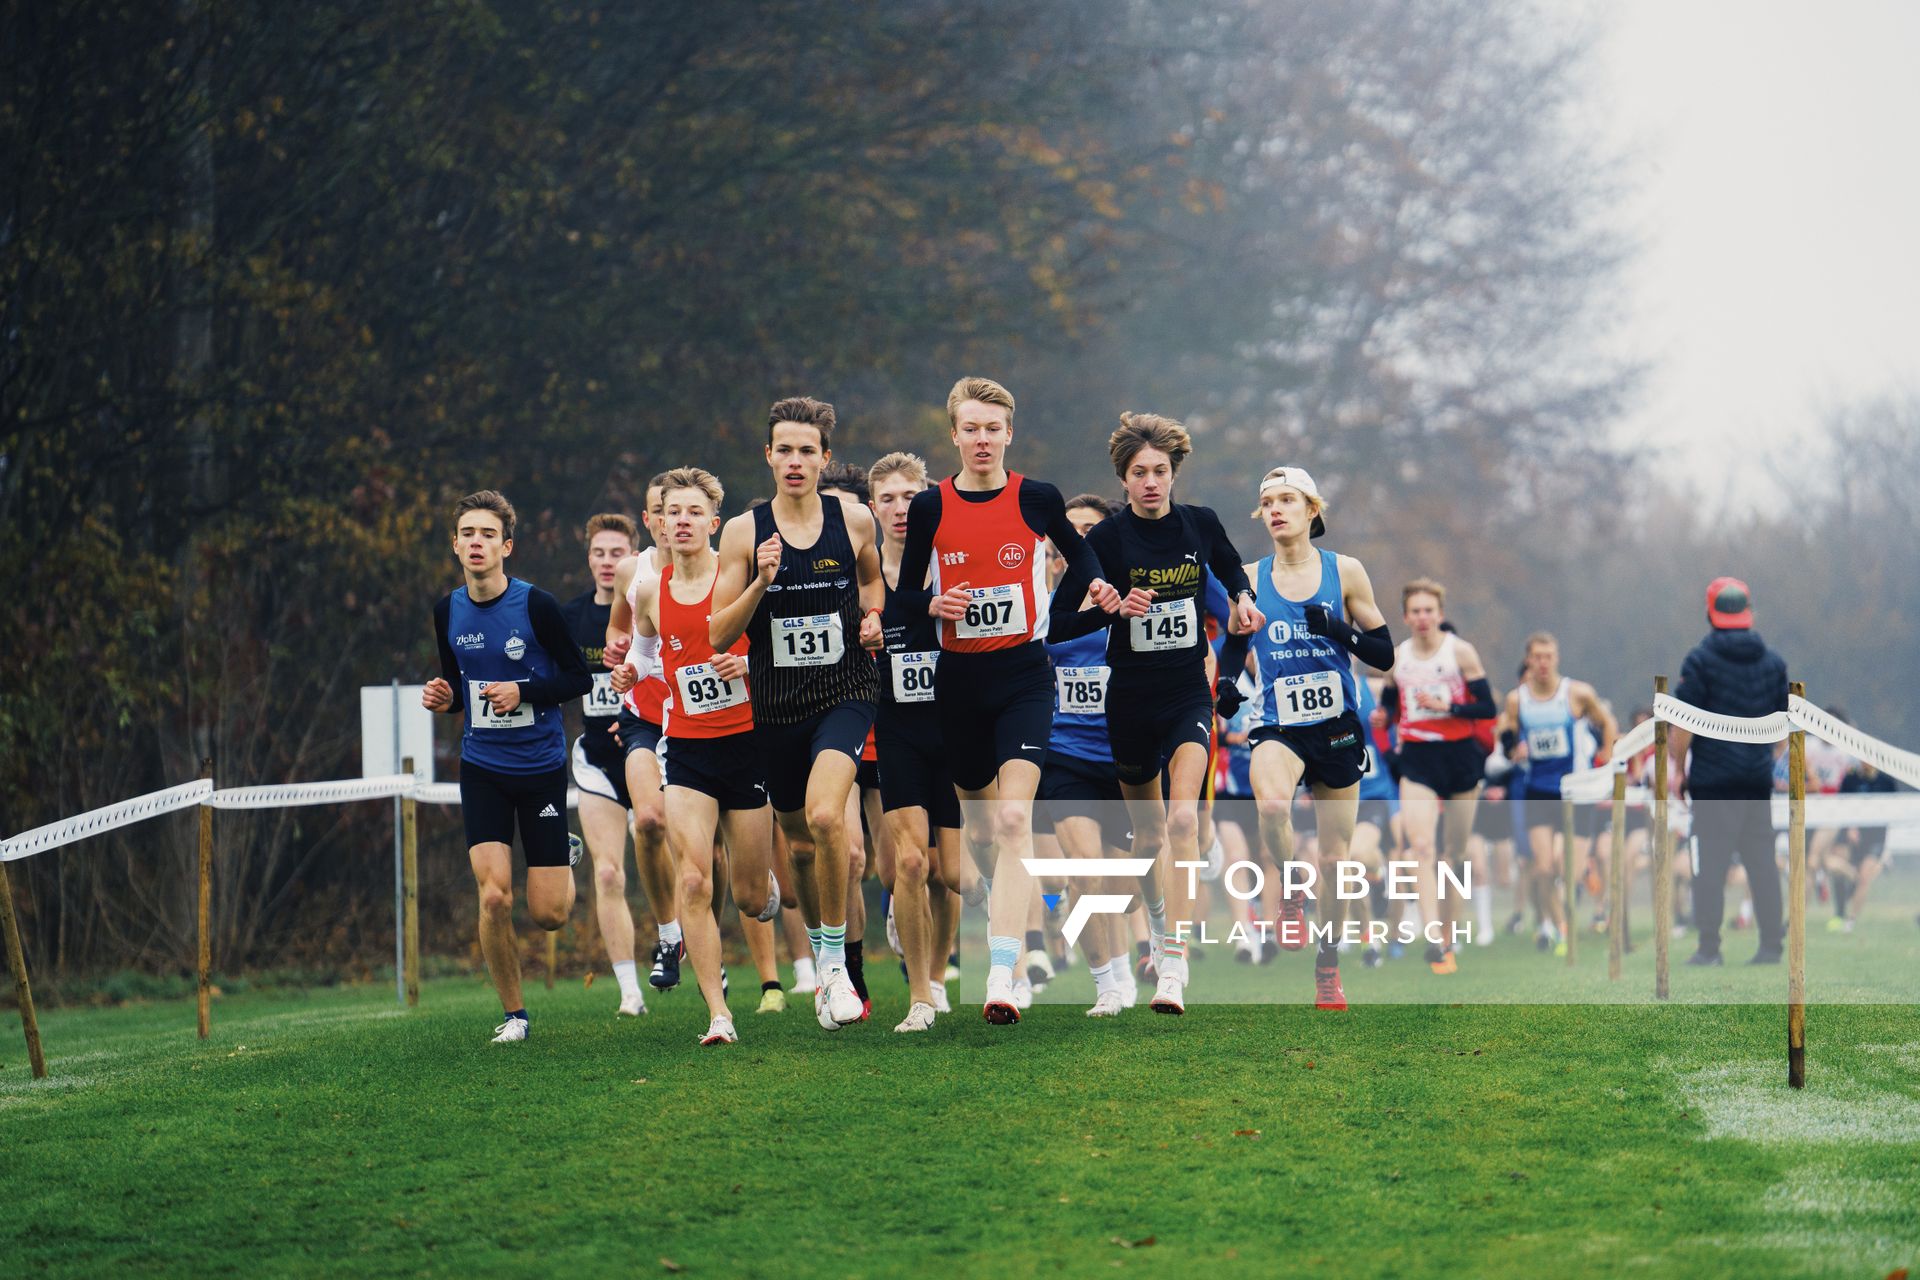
[1580,0,1920,505]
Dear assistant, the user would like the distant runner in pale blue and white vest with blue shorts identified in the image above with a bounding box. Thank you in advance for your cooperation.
[1488,631,1619,956]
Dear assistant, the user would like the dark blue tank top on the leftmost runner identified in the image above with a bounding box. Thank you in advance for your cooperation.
[447,578,566,773]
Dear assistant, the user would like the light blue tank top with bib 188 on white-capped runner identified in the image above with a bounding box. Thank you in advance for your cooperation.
[1250,551,1359,729]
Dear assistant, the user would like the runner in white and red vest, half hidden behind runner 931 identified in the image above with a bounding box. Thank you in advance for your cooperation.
[601,476,687,990]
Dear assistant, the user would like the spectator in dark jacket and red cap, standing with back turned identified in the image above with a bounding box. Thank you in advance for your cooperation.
[1668,578,1788,965]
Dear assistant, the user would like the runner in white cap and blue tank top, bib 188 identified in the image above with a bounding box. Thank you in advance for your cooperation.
[1225,466,1394,1009]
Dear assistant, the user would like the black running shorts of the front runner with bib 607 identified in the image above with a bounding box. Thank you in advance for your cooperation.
[933,641,1054,791]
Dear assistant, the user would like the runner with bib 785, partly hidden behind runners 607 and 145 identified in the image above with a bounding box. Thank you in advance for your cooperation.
[1039,493,1165,1017]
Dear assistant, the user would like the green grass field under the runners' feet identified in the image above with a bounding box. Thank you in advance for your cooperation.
[0,901,1920,1280]
